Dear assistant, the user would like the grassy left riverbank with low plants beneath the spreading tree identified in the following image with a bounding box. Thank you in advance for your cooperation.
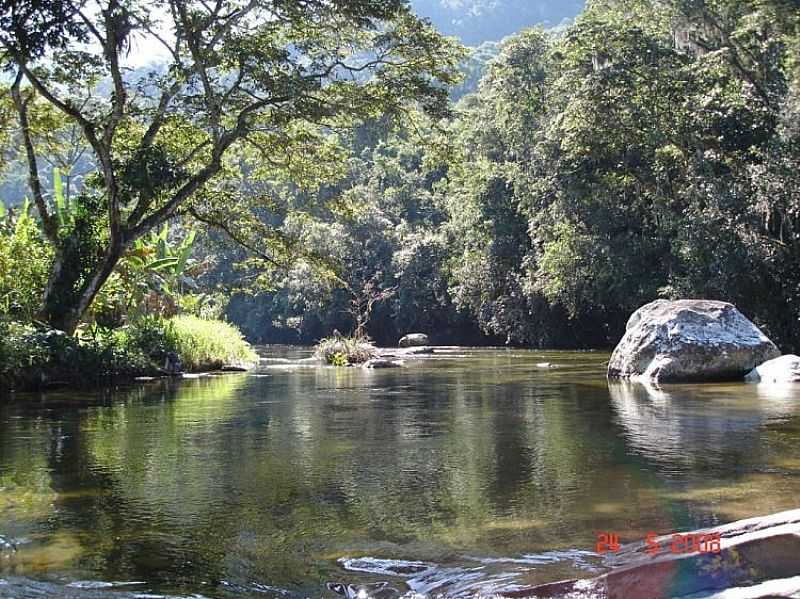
[0,316,258,390]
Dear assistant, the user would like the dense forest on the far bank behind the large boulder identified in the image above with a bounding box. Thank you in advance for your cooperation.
[223,2,800,348]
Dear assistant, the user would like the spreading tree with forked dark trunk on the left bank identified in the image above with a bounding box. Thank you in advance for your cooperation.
[0,0,461,332]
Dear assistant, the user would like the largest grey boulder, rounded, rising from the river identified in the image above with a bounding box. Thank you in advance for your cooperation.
[608,300,780,383]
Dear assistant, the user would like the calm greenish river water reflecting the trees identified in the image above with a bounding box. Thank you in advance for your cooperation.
[0,348,800,597]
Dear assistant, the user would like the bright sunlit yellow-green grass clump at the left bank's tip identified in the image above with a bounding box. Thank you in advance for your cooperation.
[164,315,258,371]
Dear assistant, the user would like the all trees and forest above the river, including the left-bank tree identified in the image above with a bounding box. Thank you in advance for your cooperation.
[0,0,800,378]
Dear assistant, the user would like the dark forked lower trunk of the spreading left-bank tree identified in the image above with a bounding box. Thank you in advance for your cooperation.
[39,238,122,335]
